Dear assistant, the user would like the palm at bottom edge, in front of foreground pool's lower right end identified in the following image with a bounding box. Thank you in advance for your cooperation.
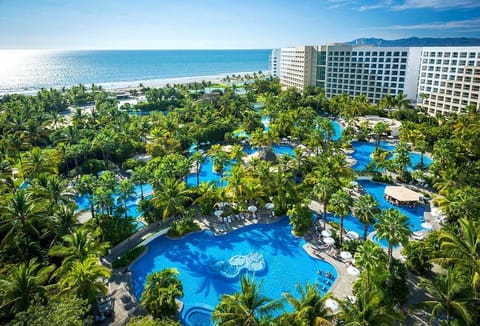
[283,283,334,326]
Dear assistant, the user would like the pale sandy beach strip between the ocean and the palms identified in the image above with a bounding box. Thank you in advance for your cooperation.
[0,71,270,97]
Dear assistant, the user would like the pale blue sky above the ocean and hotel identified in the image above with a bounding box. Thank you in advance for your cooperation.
[0,0,480,49]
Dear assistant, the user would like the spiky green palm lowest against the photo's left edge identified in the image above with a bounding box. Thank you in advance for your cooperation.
[0,258,55,314]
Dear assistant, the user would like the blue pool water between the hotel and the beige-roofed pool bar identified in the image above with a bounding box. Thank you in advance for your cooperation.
[352,141,432,171]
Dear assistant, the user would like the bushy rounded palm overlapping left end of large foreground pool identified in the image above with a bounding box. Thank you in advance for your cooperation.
[142,268,183,318]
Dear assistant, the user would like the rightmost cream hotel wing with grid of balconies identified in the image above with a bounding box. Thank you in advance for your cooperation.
[418,46,480,114]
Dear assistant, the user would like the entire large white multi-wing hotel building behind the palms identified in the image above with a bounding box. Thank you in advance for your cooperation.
[272,44,480,114]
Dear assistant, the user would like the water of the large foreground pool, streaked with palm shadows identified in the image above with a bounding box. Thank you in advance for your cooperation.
[131,217,337,325]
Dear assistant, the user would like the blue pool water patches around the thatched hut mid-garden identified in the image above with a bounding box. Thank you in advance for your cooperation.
[187,145,295,187]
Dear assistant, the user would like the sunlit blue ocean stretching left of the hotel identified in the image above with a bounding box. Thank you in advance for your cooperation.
[0,49,271,95]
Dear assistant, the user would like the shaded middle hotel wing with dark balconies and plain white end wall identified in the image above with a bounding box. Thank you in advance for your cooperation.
[315,44,421,103]
